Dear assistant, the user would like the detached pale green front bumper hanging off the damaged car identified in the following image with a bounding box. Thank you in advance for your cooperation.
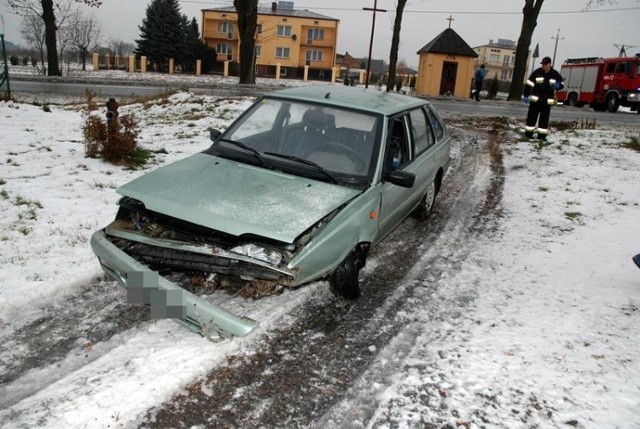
[91,230,258,341]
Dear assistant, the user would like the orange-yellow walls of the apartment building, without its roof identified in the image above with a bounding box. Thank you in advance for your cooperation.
[202,10,339,70]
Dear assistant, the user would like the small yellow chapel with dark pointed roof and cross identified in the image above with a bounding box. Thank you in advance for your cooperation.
[416,28,478,97]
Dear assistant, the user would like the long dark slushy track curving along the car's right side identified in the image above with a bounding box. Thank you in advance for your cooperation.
[142,118,500,428]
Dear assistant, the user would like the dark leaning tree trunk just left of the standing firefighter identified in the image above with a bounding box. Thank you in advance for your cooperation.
[507,0,544,100]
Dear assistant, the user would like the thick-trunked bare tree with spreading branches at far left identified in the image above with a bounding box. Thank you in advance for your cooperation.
[6,0,102,76]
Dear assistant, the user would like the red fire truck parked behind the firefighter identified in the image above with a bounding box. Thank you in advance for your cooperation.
[557,54,640,113]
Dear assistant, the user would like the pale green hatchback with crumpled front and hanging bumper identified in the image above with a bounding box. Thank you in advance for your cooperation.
[91,85,451,337]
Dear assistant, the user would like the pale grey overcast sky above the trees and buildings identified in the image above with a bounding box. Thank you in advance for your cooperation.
[0,0,640,66]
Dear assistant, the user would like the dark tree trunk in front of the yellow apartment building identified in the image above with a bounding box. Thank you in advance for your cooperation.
[233,0,258,84]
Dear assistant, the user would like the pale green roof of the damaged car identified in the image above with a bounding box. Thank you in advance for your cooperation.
[265,85,429,116]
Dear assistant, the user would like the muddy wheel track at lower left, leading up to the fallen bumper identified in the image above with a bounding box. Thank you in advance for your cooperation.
[0,278,150,408]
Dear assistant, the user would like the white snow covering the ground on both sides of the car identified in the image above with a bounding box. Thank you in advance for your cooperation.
[0,88,640,428]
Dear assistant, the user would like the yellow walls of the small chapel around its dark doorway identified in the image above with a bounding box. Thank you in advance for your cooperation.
[416,52,475,98]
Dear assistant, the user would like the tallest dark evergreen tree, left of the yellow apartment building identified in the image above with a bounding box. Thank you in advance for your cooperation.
[135,0,184,71]
